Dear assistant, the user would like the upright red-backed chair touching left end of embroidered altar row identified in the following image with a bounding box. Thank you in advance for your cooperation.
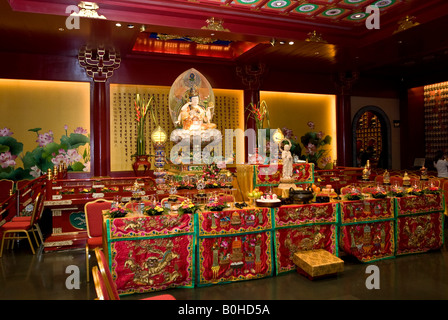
[84,199,112,282]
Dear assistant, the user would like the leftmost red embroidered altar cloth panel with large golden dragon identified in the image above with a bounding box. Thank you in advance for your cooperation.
[104,214,195,295]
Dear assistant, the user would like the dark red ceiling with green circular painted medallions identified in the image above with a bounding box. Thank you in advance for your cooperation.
[0,0,448,79]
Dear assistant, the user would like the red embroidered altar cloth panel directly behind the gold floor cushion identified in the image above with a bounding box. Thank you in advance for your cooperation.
[272,202,338,274]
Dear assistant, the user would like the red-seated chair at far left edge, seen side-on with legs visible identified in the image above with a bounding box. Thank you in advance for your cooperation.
[0,193,44,257]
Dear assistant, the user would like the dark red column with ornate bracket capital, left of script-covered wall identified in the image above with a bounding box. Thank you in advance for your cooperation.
[78,46,121,177]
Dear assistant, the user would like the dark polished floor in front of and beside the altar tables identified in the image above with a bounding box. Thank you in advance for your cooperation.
[0,229,448,300]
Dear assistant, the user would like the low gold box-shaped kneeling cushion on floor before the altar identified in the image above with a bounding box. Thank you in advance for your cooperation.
[293,249,344,280]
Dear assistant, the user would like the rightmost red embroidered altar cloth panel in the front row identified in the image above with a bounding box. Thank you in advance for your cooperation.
[395,194,445,255]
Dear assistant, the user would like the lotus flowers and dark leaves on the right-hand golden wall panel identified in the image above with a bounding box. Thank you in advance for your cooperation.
[300,121,331,168]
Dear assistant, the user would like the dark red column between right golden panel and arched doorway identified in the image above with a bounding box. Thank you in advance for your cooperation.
[336,72,358,167]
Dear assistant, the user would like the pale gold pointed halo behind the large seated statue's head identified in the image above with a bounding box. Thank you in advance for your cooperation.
[169,68,215,126]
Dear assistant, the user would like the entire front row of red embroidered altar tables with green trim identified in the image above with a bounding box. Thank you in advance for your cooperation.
[104,194,445,294]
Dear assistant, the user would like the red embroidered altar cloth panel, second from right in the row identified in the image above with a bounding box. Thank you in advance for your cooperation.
[339,198,395,262]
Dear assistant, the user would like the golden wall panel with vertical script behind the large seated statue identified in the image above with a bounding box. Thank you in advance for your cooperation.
[110,84,244,171]
